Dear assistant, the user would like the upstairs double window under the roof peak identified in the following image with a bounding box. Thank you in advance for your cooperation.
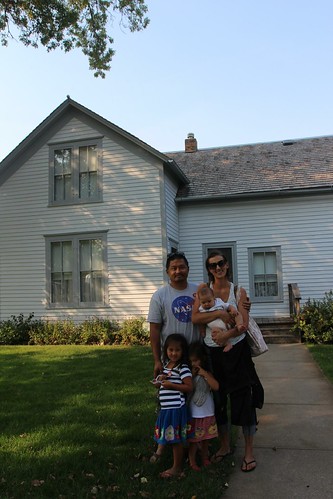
[50,140,102,205]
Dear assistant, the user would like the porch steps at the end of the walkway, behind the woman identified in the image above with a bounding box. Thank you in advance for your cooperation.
[255,317,301,344]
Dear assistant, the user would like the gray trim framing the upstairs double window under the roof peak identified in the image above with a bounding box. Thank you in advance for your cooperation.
[48,137,103,206]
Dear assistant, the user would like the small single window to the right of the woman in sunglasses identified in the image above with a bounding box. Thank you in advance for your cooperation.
[249,247,282,302]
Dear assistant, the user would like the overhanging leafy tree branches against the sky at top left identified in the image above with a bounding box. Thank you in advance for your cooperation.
[0,0,149,78]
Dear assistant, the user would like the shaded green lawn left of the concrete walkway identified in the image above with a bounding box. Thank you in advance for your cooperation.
[0,346,233,499]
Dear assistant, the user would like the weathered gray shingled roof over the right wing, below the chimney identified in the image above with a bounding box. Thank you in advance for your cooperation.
[166,137,333,201]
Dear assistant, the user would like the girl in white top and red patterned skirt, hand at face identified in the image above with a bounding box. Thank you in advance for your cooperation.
[189,342,219,471]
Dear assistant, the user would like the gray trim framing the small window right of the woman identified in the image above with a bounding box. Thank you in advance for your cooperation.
[248,246,283,303]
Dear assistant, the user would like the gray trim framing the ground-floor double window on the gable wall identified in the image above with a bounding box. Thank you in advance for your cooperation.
[44,231,109,309]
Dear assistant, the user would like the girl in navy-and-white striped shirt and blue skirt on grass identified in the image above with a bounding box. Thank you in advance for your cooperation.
[154,334,192,478]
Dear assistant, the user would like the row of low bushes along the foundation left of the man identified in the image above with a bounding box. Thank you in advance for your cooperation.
[0,314,149,345]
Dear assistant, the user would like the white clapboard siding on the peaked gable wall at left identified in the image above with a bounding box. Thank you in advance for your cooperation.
[0,119,165,321]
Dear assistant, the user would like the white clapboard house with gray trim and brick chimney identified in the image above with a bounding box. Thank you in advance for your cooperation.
[0,98,333,321]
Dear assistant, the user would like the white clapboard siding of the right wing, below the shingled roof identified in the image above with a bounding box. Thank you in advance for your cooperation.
[179,195,333,317]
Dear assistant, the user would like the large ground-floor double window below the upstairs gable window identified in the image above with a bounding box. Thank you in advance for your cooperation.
[46,233,108,307]
